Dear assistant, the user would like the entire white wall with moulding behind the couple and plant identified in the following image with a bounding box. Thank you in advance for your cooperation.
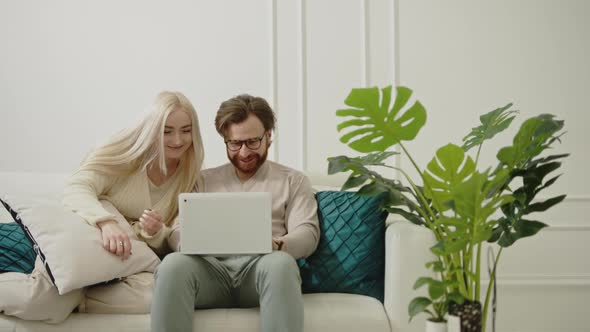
[0,0,590,331]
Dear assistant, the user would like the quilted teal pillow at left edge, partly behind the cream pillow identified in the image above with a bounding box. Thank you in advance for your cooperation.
[0,200,37,274]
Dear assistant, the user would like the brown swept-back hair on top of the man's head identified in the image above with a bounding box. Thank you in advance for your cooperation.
[215,94,276,138]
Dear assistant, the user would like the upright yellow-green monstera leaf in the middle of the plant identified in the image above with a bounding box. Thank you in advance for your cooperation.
[423,144,475,212]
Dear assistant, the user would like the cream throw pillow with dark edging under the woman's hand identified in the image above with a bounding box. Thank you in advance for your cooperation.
[2,195,160,295]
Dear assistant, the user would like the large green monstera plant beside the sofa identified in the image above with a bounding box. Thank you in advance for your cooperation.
[328,86,567,330]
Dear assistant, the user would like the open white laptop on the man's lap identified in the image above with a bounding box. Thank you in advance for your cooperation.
[178,192,272,256]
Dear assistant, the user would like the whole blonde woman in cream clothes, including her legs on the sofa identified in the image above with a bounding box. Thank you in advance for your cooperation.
[0,92,204,323]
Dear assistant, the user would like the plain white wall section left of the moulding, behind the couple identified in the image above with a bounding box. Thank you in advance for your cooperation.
[0,0,274,172]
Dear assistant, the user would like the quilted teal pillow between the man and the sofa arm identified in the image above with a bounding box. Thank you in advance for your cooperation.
[298,191,387,302]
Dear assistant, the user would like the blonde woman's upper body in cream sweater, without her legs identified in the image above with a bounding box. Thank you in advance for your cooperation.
[63,92,204,259]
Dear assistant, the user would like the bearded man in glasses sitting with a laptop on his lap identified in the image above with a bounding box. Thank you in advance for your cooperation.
[151,95,319,332]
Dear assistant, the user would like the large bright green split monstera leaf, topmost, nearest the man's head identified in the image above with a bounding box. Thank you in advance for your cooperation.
[336,86,426,153]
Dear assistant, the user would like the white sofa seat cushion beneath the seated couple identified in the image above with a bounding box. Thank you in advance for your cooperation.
[0,294,398,332]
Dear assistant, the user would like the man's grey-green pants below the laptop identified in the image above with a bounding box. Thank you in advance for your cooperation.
[151,251,303,332]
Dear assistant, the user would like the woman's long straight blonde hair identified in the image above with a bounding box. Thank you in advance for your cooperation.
[80,91,205,225]
